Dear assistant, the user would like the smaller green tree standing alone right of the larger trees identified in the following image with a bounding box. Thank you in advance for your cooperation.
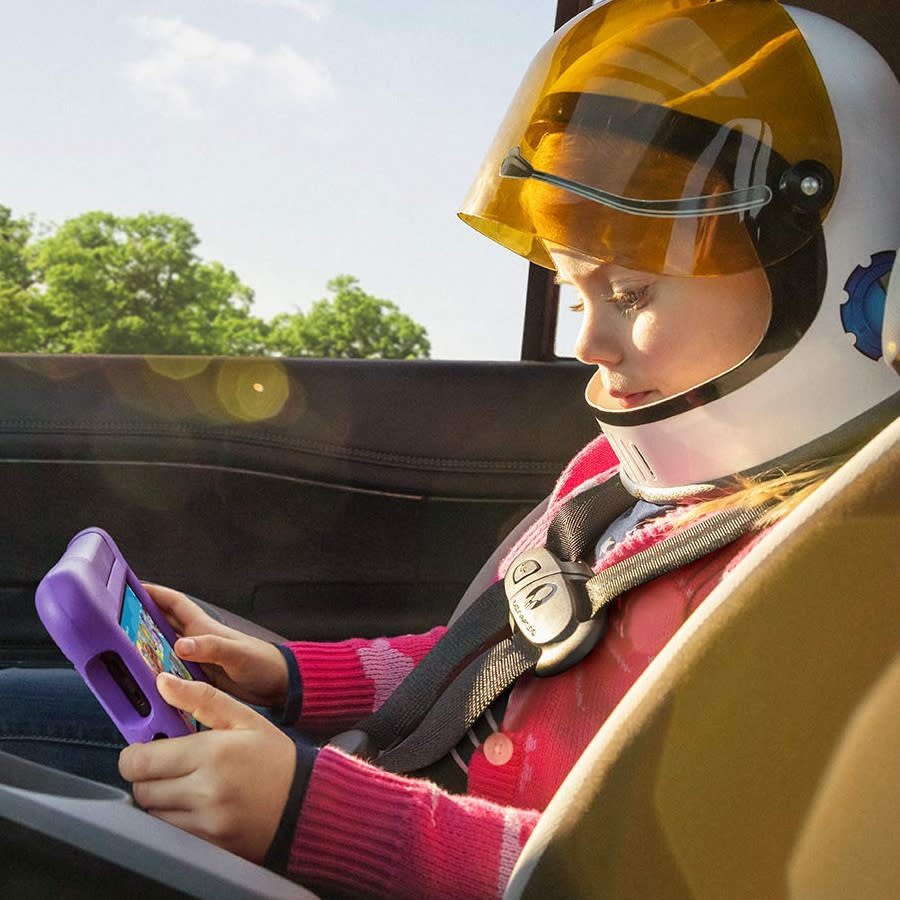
[266,275,431,359]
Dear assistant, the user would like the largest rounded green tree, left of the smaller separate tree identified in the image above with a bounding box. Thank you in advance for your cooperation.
[17,212,266,354]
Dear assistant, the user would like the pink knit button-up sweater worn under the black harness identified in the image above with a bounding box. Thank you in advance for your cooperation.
[280,438,755,898]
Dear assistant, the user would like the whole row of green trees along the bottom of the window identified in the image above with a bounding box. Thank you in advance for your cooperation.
[0,206,429,359]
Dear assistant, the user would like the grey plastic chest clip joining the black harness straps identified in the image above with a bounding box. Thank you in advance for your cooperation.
[503,548,605,676]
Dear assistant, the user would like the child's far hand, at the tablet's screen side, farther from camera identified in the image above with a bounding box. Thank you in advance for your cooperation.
[144,584,288,706]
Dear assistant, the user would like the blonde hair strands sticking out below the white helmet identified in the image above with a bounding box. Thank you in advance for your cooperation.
[678,453,851,529]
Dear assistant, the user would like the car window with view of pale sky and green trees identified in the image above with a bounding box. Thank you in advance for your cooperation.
[0,0,555,359]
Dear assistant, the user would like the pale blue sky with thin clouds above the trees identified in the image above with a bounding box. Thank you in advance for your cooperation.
[0,0,580,359]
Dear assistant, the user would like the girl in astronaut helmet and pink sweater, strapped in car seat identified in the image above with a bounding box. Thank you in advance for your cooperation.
[1,0,900,897]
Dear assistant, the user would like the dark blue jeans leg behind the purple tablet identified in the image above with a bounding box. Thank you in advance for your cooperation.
[0,669,129,790]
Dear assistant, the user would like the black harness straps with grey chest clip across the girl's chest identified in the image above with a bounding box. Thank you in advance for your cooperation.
[329,476,768,772]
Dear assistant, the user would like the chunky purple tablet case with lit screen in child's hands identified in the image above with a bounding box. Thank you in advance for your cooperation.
[35,528,206,743]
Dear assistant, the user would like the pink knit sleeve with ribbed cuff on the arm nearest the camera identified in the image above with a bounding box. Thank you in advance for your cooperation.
[289,747,539,900]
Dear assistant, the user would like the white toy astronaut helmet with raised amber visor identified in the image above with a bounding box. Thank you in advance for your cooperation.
[460,0,900,500]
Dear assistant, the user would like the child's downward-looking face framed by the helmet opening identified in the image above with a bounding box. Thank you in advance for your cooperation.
[548,244,771,410]
